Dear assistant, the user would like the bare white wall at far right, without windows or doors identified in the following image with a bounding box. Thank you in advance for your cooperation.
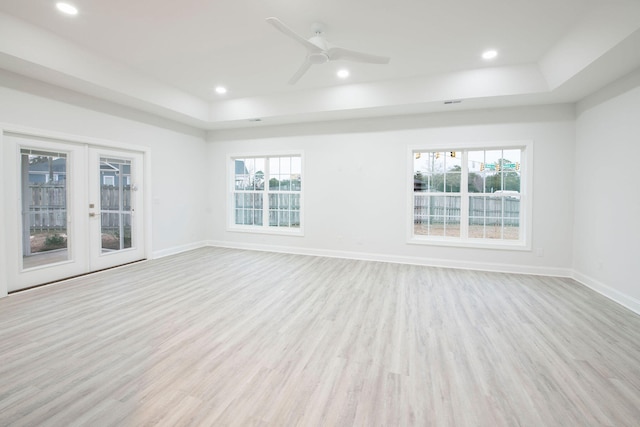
[573,71,640,313]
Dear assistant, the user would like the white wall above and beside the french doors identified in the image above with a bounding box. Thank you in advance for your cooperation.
[0,71,207,256]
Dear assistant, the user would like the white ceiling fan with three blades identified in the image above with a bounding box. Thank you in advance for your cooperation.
[267,18,390,85]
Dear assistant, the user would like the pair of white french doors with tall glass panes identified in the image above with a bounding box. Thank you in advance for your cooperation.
[3,133,145,292]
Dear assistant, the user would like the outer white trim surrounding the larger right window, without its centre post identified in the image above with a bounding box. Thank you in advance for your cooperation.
[406,140,533,251]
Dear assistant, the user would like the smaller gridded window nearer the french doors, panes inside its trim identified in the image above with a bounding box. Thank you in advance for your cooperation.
[230,155,302,234]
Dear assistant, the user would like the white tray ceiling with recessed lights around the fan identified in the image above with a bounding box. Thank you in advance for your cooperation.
[0,0,640,129]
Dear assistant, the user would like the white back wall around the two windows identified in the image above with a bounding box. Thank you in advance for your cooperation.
[207,105,575,275]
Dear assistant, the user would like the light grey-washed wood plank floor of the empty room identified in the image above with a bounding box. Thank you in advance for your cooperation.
[0,248,640,427]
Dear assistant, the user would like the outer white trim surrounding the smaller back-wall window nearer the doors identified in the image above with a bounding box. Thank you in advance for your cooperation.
[226,150,305,237]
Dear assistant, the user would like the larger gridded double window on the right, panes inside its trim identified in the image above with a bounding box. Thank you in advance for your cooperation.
[411,146,529,247]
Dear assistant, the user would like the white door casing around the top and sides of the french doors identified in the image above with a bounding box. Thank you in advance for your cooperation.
[0,122,153,298]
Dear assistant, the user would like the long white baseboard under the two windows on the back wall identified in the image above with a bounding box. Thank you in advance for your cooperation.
[207,240,572,277]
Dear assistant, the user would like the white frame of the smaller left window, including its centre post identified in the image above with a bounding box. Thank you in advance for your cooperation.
[226,150,305,236]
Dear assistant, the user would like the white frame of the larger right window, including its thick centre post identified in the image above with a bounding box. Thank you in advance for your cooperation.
[406,140,533,251]
